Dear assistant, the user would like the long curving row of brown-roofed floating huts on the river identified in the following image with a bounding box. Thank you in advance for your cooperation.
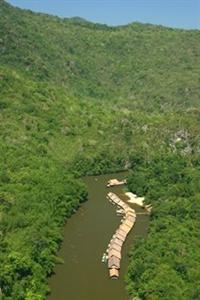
[107,192,136,279]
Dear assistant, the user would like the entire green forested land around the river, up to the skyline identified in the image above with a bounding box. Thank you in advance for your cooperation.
[0,0,200,300]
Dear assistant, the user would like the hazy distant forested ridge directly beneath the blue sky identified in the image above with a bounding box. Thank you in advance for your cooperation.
[0,0,200,105]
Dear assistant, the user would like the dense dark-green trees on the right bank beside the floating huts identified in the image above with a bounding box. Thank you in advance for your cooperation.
[126,153,200,300]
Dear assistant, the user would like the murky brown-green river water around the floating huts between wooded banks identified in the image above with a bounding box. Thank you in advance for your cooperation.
[47,172,149,300]
